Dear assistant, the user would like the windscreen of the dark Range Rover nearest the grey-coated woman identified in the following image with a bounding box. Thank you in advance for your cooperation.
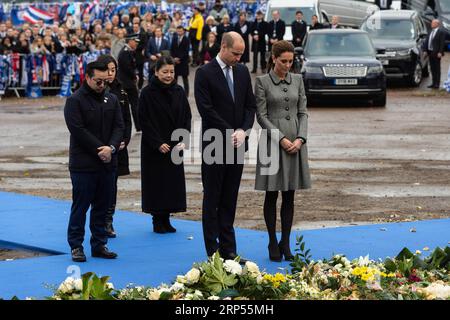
[305,32,375,57]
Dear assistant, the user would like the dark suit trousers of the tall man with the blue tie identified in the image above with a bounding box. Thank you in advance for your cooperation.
[202,162,244,257]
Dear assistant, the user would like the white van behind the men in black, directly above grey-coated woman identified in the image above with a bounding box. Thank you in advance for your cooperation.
[265,0,328,41]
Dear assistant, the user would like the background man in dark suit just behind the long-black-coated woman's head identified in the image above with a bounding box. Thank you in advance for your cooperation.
[170,26,190,97]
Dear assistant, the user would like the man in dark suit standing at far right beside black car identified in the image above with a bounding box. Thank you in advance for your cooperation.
[423,19,445,89]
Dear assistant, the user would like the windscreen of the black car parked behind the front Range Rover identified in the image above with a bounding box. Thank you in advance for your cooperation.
[361,18,416,40]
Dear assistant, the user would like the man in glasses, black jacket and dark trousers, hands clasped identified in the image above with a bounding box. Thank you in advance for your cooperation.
[64,62,124,262]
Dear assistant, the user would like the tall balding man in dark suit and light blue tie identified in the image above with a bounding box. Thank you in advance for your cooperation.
[195,31,256,263]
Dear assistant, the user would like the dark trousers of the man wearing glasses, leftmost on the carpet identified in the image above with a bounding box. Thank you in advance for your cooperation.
[67,170,115,251]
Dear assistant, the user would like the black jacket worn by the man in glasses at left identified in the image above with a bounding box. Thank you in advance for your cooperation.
[64,82,125,172]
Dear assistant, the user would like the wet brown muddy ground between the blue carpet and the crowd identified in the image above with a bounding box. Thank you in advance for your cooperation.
[0,55,450,254]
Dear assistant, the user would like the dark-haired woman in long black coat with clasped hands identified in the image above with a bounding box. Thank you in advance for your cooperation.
[139,56,192,233]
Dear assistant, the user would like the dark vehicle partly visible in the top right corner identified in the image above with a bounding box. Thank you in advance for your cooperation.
[402,0,450,45]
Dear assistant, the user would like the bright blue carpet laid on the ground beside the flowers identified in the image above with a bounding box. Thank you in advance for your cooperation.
[0,192,450,299]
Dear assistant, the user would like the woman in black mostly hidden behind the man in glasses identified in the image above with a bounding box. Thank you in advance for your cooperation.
[97,55,131,238]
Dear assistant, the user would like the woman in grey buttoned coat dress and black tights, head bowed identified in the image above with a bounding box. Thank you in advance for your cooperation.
[255,40,311,261]
